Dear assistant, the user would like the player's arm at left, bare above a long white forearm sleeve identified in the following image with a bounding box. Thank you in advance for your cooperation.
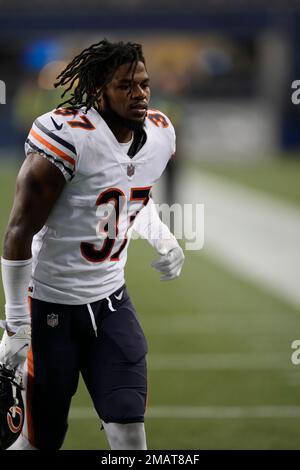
[1,154,65,338]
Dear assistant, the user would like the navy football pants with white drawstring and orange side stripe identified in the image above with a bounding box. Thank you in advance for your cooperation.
[26,286,147,449]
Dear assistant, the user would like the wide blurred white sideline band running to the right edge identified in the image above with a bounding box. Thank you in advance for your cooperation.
[179,168,300,308]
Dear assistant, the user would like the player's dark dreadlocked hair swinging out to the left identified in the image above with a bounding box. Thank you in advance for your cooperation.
[54,39,145,112]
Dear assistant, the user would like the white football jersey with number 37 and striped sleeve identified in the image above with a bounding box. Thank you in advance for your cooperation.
[25,108,175,305]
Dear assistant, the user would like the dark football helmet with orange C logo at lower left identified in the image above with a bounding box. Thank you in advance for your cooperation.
[0,364,24,450]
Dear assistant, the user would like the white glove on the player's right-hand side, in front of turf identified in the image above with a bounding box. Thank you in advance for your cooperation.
[151,239,184,281]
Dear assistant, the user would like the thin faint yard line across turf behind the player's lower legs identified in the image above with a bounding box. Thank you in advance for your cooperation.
[70,406,300,419]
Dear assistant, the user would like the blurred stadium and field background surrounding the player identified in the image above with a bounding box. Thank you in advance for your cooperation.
[0,0,300,449]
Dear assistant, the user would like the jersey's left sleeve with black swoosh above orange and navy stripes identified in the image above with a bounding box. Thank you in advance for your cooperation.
[25,110,77,181]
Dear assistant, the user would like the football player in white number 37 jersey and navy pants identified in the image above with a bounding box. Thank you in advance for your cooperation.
[0,40,184,450]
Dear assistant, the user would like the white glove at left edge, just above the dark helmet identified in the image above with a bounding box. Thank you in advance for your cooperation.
[0,322,31,369]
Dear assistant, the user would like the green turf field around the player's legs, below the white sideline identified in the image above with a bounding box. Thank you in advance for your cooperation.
[0,160,300,449]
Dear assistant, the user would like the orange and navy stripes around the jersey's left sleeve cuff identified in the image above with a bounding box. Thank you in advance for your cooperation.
[26,119,76,178]
